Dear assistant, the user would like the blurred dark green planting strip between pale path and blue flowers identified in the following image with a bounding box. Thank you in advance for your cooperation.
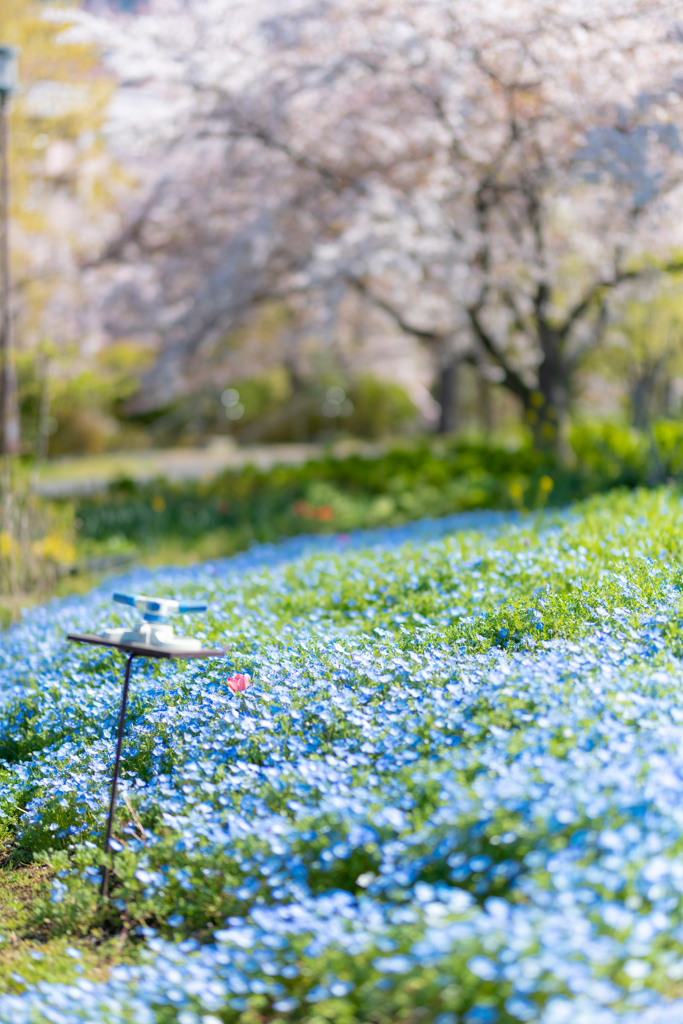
[68,421,683,555]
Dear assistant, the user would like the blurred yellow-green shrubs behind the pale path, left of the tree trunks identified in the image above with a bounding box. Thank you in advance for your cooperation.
[17,360,417,456]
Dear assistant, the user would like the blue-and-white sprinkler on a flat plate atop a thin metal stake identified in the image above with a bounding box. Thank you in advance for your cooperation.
[67,594,227,896]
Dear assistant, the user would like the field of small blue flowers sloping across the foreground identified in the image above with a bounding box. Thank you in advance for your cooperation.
[0,489,683,1024]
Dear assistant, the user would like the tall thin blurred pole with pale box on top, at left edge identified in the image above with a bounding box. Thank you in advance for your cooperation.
[0,46,19,456]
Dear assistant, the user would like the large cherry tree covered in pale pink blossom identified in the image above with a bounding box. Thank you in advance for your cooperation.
[74,0,683,445]
